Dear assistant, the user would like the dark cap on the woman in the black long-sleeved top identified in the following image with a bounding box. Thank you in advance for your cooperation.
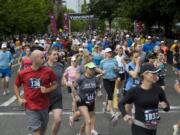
[140,64,159,74]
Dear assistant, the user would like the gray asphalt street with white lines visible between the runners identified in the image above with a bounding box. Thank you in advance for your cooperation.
[0,66,180,135]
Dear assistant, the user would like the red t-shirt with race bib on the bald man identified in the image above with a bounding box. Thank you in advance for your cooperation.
[15,66,56,110]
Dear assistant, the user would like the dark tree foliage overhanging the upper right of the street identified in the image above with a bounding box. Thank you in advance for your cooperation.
[90,0,180,30]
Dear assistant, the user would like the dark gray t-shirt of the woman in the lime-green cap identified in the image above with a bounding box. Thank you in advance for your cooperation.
[77,75,99,102]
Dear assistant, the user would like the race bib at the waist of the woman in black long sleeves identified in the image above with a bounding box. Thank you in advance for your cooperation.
[144,109,160,128]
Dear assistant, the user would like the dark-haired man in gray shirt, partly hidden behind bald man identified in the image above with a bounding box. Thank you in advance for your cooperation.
[45,49,64,135]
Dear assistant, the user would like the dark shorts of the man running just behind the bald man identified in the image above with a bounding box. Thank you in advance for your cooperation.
[49,97,63,112]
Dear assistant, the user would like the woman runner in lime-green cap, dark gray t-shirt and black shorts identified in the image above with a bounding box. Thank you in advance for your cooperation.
[73,62,99,135]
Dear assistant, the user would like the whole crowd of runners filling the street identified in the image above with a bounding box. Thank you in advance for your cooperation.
[0,32,180,135]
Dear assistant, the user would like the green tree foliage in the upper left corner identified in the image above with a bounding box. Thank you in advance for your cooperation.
[0,0,53,34]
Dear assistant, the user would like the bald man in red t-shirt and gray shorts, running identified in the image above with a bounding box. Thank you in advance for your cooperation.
[14,50,57,135]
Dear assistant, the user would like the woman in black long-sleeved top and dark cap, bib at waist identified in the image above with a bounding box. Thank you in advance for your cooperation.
[119,64,169,135]
